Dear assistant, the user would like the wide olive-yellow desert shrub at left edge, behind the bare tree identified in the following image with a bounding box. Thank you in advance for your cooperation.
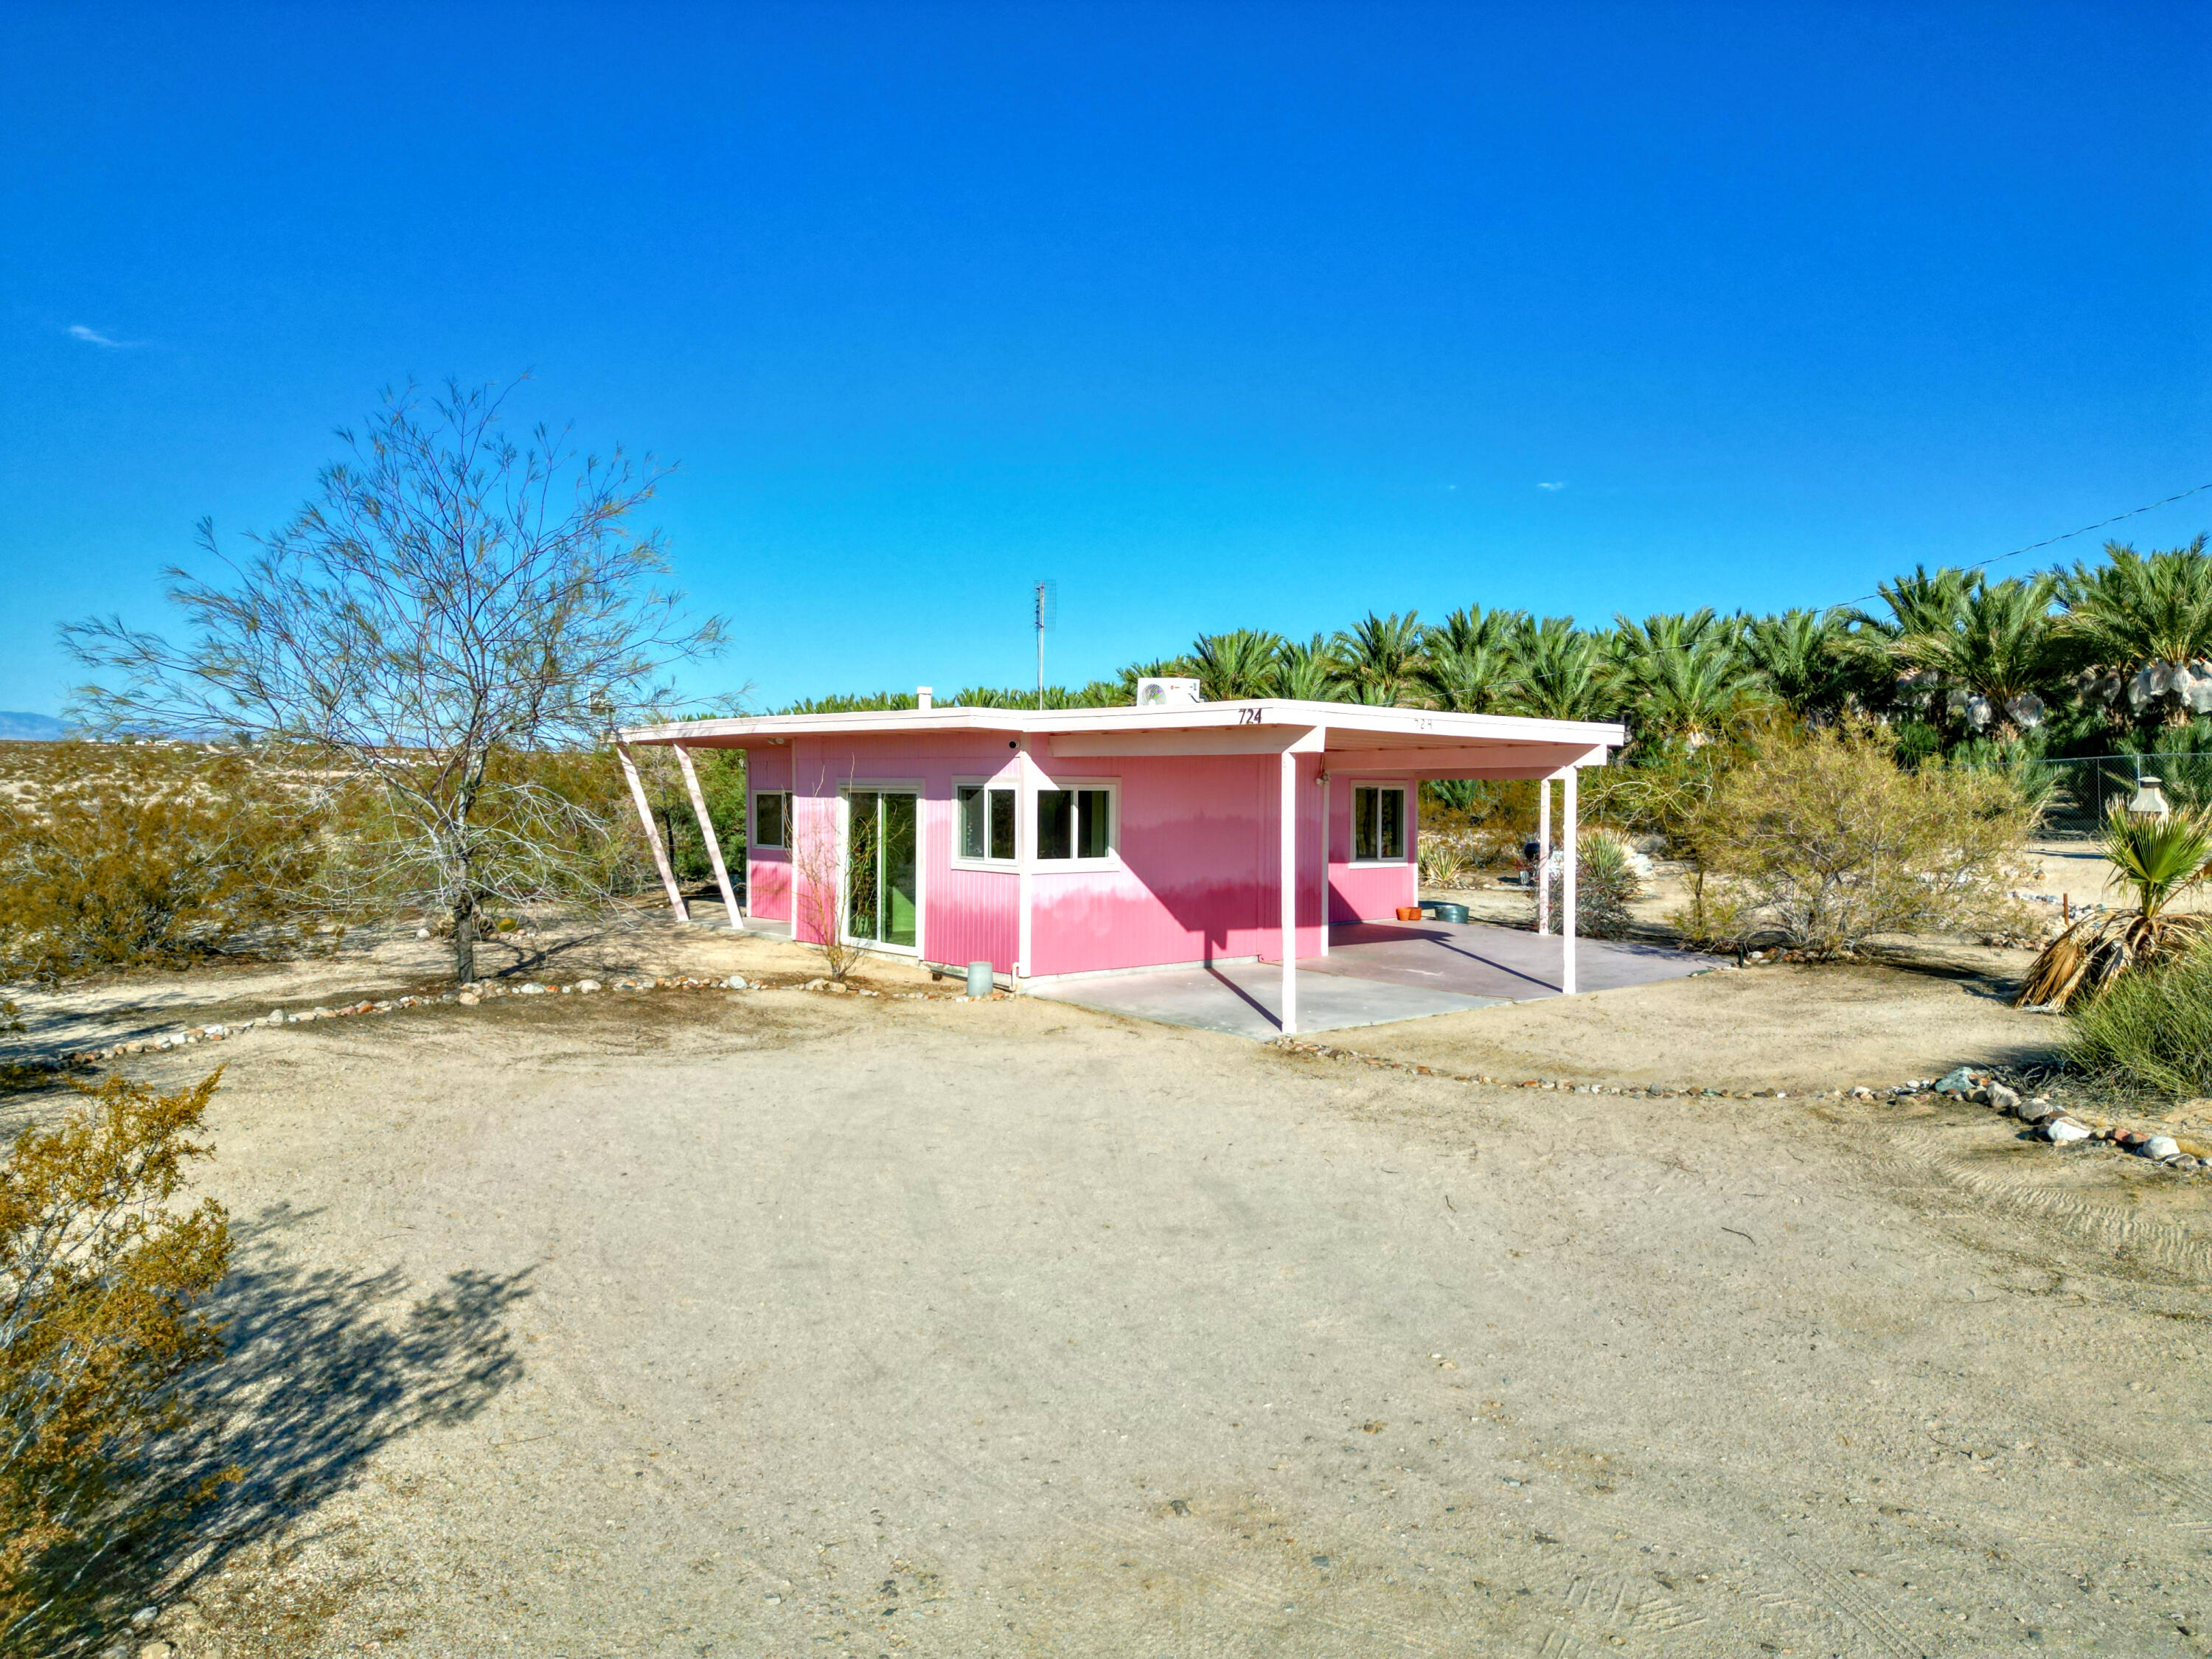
[0,743,327,982]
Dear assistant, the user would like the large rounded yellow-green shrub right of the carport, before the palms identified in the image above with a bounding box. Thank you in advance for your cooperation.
[1674,723,2033,958]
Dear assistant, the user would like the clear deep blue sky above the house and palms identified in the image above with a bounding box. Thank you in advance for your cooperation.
[0,0,2212,712]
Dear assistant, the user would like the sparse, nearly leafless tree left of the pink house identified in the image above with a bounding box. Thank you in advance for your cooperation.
[62,383,723,980]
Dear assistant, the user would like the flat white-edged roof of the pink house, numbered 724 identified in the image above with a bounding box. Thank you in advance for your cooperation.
[617,697,1628,752]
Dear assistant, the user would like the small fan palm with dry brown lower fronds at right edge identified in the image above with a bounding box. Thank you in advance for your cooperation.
[2013,801,2212,1009]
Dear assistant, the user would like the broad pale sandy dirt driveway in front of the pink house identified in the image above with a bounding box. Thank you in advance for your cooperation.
[38,991,2212,1659]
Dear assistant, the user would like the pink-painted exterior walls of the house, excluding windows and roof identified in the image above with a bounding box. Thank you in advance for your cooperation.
[708,732,1336,975]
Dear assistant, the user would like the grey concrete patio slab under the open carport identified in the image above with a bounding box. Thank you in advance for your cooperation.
[1035,922,1712,1040]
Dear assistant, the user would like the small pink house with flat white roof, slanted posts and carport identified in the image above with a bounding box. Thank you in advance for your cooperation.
[619,681,1624,1031]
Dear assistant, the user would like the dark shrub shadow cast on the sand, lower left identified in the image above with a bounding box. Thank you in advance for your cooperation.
[20,1206,531,1652]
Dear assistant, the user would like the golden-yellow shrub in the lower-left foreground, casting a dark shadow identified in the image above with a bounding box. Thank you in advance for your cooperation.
[0,1073,230,1652]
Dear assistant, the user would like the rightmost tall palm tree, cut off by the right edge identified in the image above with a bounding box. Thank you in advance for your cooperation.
[2059,535,2212,726]
